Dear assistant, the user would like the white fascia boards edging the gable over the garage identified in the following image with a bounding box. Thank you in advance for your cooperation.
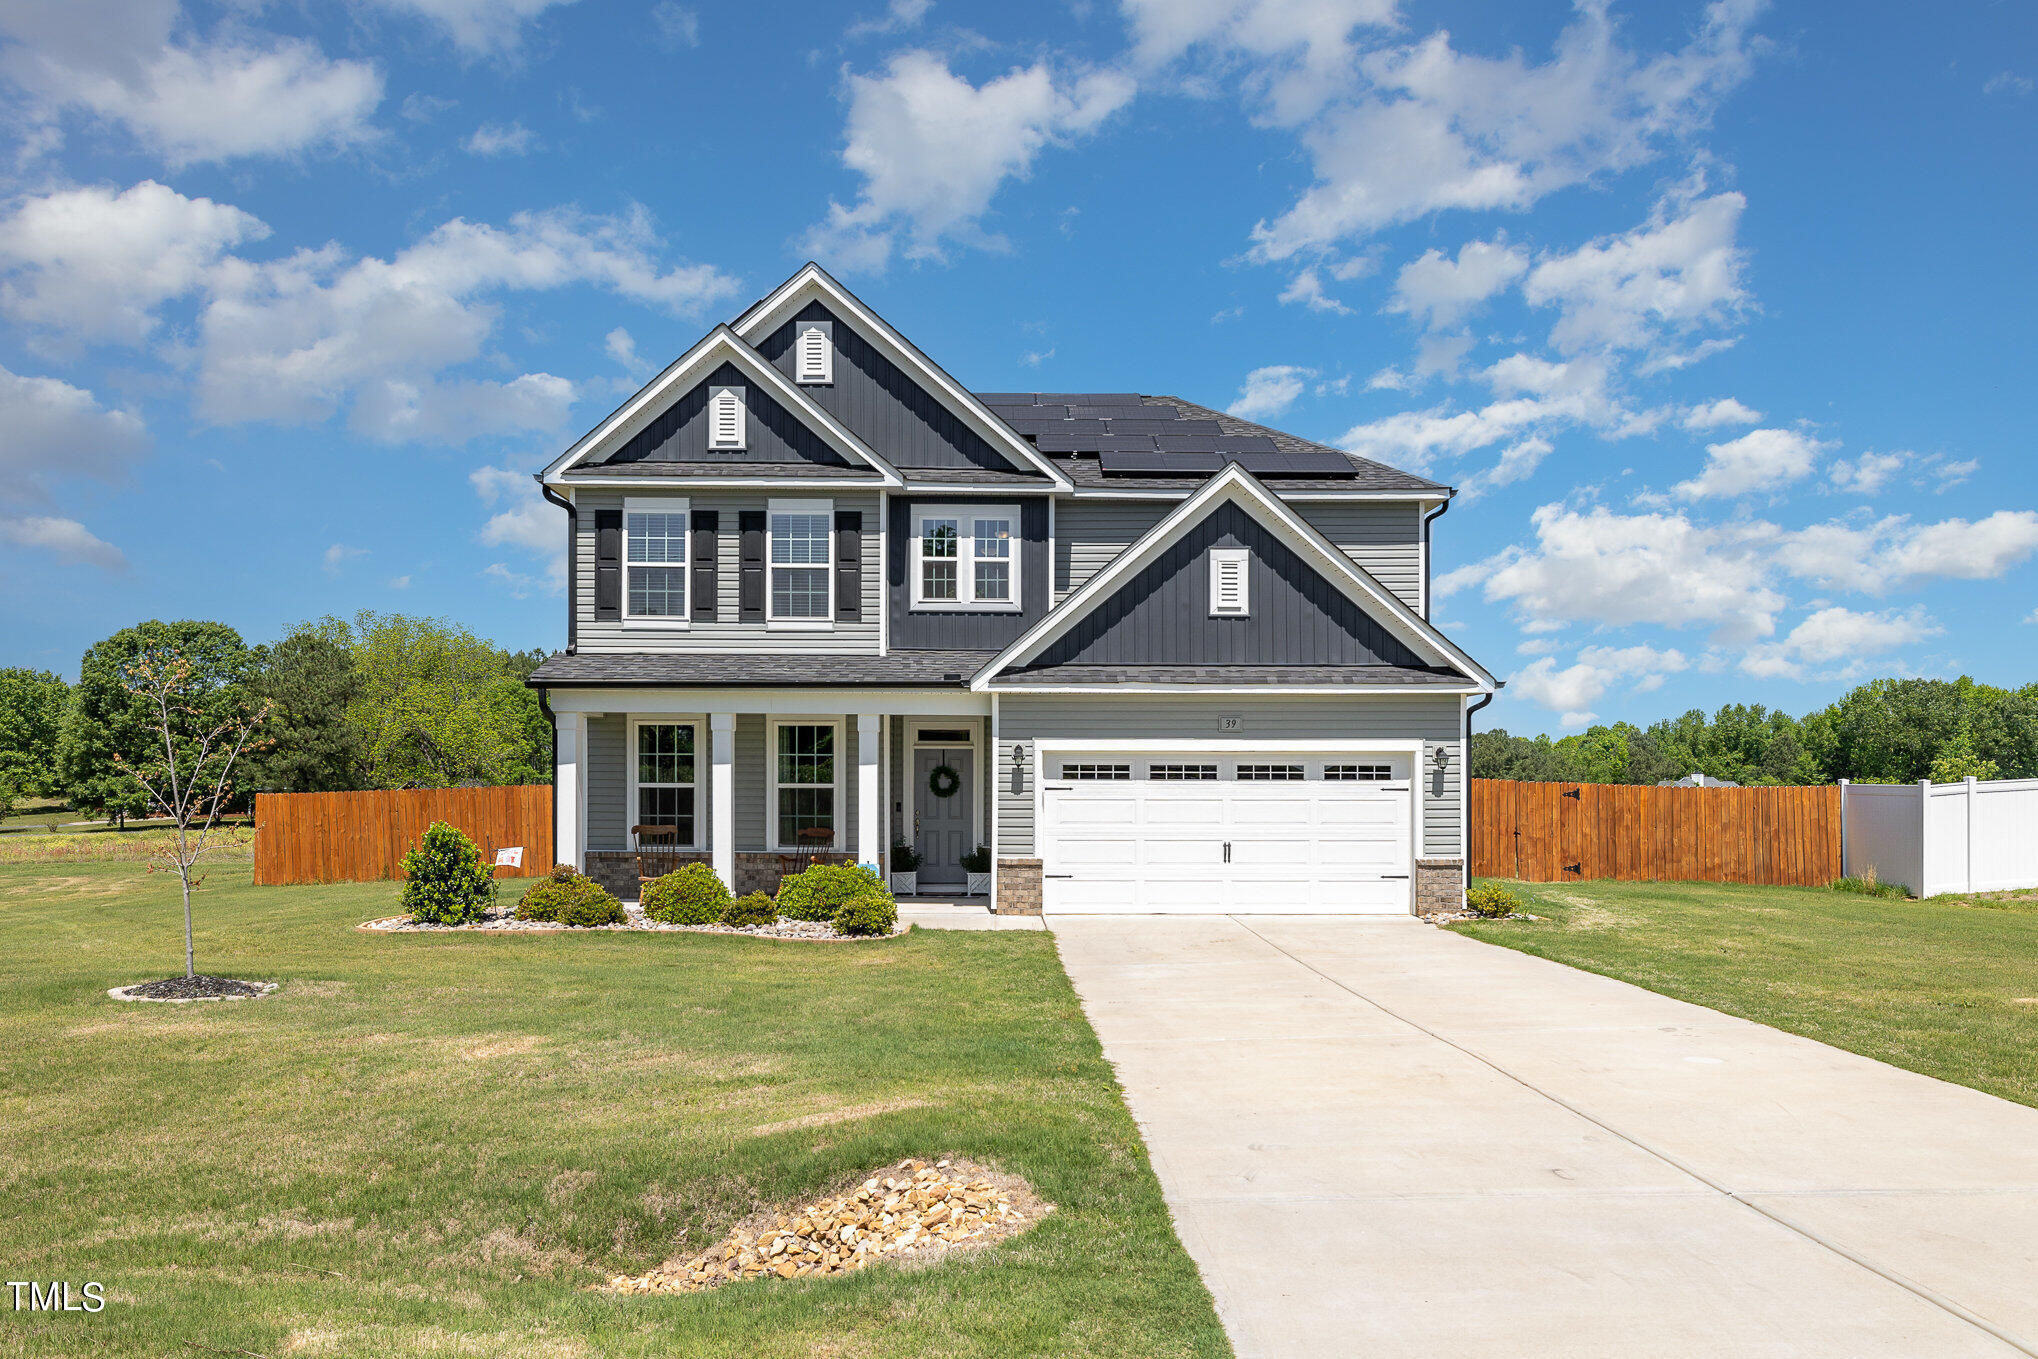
[970,463,1500,693]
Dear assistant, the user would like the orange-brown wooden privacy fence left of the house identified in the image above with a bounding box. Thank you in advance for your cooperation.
[255,784,552,884]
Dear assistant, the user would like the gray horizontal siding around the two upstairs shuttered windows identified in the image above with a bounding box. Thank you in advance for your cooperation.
[573,489,884,654]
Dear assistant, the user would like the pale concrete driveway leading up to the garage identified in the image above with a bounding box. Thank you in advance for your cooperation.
[1050,917,2038,1359]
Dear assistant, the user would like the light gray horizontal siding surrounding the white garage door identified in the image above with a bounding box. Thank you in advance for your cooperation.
[993,695,1465,858]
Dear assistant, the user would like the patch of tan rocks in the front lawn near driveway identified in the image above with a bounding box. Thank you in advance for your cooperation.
[601,1159,1054,1294]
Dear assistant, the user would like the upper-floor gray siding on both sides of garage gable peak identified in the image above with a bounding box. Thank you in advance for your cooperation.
[1054,499,1423,609]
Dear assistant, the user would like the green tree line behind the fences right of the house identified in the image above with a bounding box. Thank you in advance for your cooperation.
[1471,676,2038,786]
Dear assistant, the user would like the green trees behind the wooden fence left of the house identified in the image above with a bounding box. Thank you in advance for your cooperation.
[0,613,552,817]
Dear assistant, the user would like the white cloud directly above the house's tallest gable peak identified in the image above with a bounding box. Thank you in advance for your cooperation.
[807,51,1133,269]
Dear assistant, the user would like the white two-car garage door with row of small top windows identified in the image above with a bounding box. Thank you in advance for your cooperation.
[1039,752,1414,915]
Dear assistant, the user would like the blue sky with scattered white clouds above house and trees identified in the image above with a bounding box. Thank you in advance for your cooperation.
[0,0,2038,731]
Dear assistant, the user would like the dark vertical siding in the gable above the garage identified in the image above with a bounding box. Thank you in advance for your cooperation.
[1029,505,1425,668]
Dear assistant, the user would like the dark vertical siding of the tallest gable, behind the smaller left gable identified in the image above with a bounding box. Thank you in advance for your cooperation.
[758,302,1029,473]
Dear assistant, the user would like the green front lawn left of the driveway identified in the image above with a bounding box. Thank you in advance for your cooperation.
[0,862,1229,1359]
